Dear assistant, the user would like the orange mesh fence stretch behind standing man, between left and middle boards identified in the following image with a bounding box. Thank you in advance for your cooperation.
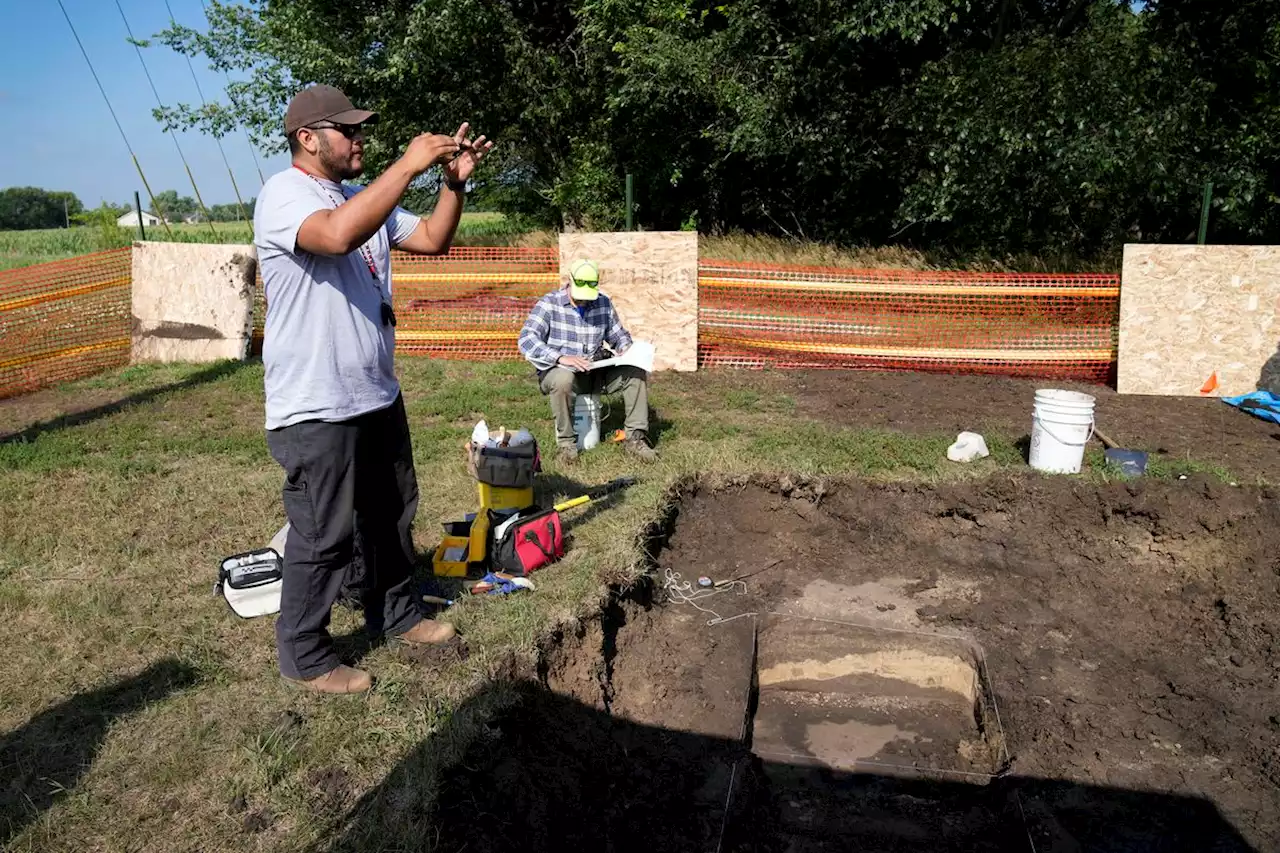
[255,246,559,361]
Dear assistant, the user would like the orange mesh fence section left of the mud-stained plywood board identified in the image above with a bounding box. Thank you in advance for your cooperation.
[0,248,131,397]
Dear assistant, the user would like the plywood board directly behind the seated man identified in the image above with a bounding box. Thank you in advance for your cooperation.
[559,231,698,371]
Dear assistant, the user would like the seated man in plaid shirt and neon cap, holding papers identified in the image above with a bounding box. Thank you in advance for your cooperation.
[520,261,658,462]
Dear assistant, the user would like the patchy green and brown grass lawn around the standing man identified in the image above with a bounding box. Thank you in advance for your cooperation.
[0,359,1198,852]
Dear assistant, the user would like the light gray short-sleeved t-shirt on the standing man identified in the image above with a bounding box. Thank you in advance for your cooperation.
[253,167,421,429]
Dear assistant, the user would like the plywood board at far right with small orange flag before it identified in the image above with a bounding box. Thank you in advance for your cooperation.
[1116,245,1280,397]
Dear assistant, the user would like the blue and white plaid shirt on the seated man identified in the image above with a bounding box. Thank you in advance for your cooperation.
[520,289,631,373]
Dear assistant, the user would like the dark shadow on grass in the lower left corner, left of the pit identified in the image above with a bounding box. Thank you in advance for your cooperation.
[0,658,200,845]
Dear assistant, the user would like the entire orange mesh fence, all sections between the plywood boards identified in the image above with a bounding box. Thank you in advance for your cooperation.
[0,247,1120,397]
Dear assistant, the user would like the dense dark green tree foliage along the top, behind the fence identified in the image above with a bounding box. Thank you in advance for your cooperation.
[157,0,1280,254]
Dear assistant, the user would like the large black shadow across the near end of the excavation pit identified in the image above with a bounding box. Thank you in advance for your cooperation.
[317,680,1254,853]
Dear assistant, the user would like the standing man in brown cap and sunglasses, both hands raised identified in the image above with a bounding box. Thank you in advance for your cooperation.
[253,86,493,693]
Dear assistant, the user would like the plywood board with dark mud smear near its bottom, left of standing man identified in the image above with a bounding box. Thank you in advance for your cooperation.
[132,242,257,362]
